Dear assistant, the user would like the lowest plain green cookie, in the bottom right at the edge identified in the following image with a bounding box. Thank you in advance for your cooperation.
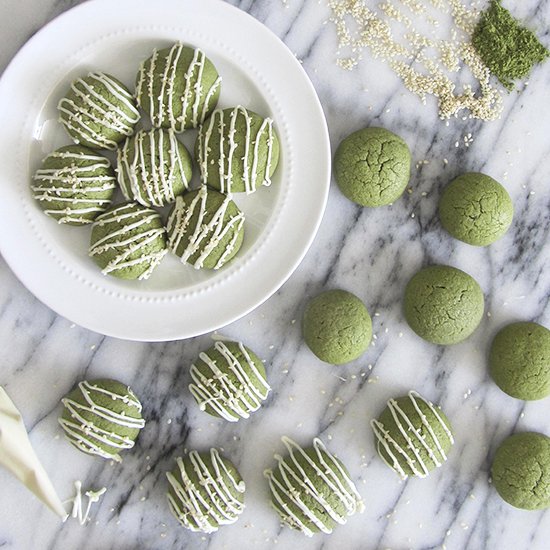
[491,432,550,510]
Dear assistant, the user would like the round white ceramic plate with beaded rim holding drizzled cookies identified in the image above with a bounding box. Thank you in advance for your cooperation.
[0,0,330,341]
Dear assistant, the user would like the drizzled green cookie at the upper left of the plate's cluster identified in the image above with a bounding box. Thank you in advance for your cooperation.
[57,72,140,151]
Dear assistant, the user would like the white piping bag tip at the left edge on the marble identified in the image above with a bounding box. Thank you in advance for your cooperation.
[0,386,67,521]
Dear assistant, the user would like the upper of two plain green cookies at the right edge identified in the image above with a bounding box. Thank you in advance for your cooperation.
[489,322,550,401]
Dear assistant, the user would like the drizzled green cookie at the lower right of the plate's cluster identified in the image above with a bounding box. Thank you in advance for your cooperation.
[166,185,244,269]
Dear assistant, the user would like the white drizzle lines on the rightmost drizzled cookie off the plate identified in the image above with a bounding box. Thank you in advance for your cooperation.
[371,391,454,479]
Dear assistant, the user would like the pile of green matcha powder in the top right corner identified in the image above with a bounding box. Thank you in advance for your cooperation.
[472,0,550,90]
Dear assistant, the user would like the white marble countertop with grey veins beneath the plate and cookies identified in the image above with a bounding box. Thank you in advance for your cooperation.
[0,0,550,550]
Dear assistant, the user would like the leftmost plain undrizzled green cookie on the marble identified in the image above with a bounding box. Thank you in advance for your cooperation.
[302,290,372,365]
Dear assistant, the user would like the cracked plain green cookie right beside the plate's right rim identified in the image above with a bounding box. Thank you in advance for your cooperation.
[334,128,411,206]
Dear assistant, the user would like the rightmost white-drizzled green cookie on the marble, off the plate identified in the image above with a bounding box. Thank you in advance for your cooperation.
[371,391,454,479]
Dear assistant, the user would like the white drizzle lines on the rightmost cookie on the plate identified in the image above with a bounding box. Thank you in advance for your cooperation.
[197,105,275,194]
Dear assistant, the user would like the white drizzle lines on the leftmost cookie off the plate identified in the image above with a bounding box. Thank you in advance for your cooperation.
[59,380,145,462]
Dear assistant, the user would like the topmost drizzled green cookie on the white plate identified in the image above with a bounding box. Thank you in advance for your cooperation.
[136,42,221,133]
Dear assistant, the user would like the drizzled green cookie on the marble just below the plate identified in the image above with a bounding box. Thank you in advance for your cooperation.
[189,341,271,422]
